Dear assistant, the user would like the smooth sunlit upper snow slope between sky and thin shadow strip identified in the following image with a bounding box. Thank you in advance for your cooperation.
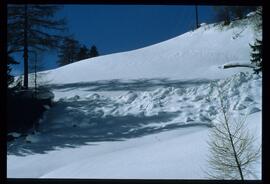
[38,19,254,84]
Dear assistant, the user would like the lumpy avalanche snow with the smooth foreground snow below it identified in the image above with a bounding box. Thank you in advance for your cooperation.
[8,72,262,179]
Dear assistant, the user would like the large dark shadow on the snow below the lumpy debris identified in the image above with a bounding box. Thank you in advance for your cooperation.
[7,97,211,156]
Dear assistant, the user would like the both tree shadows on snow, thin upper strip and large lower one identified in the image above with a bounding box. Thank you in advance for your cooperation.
[7,79,213,156]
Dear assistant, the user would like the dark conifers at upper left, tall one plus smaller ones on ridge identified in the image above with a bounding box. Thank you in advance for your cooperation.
[7,4,99,89]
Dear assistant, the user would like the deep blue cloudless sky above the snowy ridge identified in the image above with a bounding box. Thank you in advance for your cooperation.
[12,5,217,75]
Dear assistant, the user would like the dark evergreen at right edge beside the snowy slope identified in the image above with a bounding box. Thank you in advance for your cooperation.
[249,39,263,74]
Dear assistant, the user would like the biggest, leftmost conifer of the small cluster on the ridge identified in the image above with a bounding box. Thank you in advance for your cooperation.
[58,37,80,66]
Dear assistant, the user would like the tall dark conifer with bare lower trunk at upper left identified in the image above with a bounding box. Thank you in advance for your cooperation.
[7,4,65,88]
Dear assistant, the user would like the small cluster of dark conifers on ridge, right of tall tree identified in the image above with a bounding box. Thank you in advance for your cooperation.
[58,36,99,66]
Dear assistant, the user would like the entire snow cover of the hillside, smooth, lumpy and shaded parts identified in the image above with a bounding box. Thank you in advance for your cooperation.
[7,16,262,179]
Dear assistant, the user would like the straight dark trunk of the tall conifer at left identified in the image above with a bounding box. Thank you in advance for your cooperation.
[23,4,28,89]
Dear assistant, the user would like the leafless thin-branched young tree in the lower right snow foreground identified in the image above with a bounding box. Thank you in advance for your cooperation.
[206,82,261,180]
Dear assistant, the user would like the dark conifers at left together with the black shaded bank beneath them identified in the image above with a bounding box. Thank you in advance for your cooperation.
[6,4,99,136]
